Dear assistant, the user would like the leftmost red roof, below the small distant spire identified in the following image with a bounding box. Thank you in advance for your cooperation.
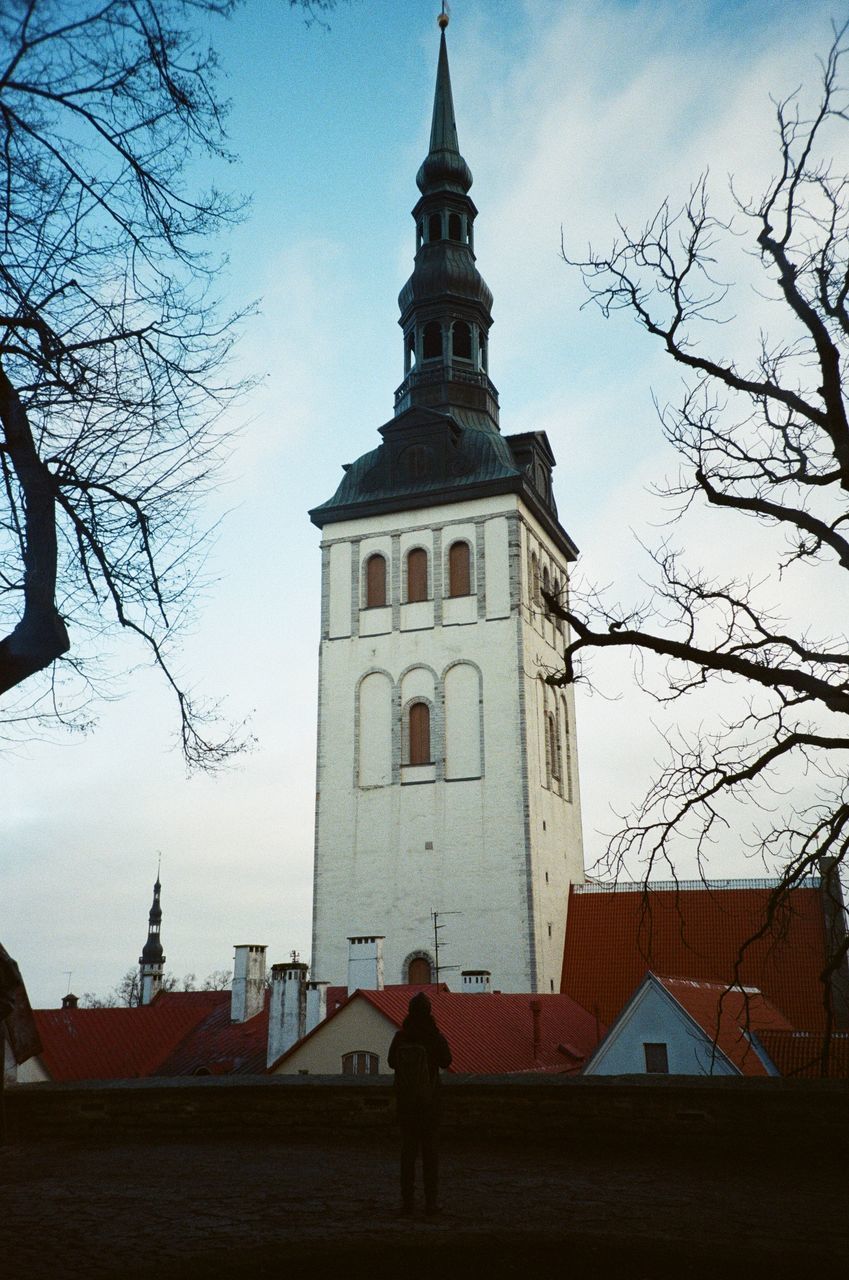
[35,991,229,1080]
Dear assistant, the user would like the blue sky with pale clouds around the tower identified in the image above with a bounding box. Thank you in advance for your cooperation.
[0,0,841,1007]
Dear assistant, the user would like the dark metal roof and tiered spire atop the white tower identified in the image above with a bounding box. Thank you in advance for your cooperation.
[310,15,578,559]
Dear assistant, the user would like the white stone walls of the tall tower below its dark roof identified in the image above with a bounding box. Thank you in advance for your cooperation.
[312,494,583,992]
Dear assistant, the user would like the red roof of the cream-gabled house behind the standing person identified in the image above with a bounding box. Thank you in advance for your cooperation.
[284,984,606,1075]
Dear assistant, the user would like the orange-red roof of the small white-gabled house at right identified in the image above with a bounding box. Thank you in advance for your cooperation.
[654,974,791,1075]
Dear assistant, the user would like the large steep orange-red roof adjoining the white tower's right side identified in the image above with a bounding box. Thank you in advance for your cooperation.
[561,881,826,1030]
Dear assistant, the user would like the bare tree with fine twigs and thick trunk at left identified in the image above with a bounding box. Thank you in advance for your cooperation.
[0,0,252,765]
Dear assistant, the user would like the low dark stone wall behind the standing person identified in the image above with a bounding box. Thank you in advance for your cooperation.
[5,1076,849,1151]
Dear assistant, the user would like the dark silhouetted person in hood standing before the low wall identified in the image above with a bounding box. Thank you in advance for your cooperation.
[388,991,451,1213]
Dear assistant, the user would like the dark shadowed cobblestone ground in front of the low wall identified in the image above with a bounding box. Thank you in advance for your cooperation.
[0,1138,849,1280]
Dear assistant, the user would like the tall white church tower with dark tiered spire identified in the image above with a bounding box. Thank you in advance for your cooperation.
[310,14,584,992]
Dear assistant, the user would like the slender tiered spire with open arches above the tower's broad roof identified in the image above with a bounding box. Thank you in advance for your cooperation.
[396,14,498,426]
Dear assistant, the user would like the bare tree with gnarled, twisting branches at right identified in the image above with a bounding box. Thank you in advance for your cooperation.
[555,27,849,1008]
